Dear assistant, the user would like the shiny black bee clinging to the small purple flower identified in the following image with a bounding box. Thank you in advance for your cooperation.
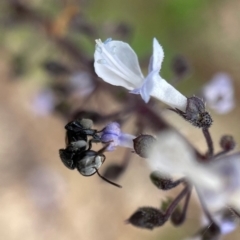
[59,119,121,187]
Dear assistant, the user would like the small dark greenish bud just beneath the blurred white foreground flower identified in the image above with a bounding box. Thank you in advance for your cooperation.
[150,171,181,190]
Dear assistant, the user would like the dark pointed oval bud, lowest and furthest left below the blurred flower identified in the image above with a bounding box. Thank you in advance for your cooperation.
[126,207,167,230]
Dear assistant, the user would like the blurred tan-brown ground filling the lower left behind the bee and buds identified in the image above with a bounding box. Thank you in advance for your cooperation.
[0,54,240,240]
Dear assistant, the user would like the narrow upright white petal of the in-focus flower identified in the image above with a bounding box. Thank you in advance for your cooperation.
[148,38,164,73]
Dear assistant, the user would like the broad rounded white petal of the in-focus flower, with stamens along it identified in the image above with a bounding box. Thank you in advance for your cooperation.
[94,40,143,90]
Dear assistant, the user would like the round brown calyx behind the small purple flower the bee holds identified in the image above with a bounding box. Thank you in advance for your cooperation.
[133,134,156,158]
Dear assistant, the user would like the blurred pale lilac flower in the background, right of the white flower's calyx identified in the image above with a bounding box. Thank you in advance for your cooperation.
[203,73,235,114]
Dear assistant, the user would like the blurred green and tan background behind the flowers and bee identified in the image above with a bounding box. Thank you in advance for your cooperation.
[0,0,240,240]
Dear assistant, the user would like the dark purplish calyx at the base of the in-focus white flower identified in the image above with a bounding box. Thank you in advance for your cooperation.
[170,97,213,129]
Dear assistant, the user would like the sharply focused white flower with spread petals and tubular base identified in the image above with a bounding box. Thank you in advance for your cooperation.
[94,38,187,111]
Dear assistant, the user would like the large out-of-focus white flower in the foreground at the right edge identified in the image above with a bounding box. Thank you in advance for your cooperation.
[147,130,240,211]
